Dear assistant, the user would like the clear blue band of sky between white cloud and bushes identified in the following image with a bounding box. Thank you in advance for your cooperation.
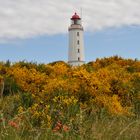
[0,26,140,63]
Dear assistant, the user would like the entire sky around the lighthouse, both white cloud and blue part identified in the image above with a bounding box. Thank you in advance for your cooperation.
[0,0,140,63]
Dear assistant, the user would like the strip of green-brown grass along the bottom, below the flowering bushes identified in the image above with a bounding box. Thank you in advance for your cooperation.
[0,109,140,140]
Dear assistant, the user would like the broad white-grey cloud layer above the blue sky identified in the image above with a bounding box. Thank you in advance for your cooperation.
[0,0,140,40]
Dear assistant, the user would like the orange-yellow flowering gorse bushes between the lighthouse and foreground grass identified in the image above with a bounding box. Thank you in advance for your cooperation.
[0,56,140,139]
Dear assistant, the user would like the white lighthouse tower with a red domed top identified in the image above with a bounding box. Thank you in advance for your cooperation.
[68,13,85,66]
